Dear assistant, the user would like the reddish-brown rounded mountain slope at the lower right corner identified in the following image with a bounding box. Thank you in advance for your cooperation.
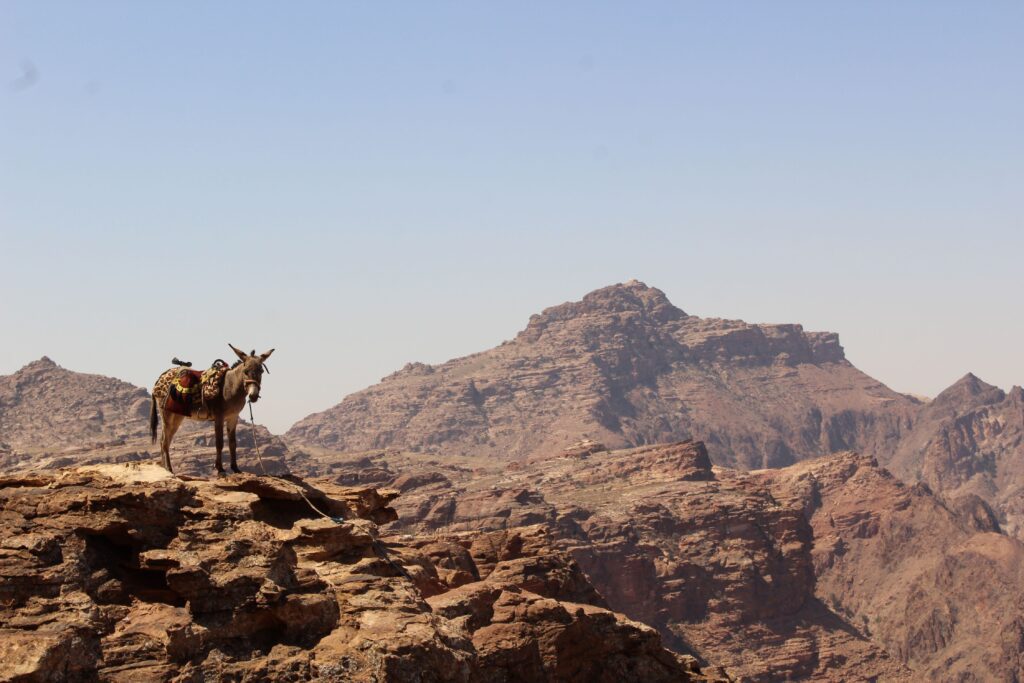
[763,454,1024,681]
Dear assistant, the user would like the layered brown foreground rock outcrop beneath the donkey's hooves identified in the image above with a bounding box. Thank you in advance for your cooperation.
[0,465,708,681]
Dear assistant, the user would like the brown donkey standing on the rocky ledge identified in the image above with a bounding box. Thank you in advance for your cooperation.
[150,344,273,475]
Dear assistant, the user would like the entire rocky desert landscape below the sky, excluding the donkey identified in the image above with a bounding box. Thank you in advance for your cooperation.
[0,281,1024,682]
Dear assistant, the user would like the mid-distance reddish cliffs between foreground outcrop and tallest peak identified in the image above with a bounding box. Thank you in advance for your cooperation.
[358,442,1024,681]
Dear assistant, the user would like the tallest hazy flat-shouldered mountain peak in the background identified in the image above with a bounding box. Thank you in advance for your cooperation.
[287,281,918,468]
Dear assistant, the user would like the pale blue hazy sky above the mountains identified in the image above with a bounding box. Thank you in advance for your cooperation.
[0,0,1024,431]
